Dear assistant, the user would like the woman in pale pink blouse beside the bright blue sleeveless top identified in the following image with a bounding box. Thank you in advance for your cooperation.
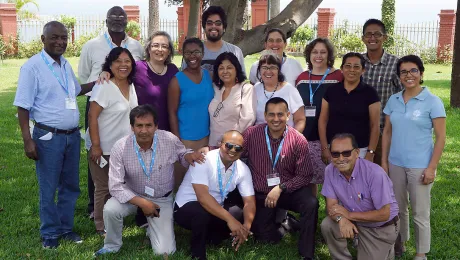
[208,52,257,148]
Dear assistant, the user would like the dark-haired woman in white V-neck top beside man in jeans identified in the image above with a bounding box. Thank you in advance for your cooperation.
[86,47,137,235]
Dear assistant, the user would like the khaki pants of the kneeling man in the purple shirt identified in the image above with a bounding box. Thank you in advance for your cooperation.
[321,217,399,260]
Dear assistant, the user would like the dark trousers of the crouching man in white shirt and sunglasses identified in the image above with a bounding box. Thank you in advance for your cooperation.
[174,190,243,260]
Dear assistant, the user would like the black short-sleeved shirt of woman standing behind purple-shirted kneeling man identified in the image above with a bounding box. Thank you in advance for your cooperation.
[324,81,380,148]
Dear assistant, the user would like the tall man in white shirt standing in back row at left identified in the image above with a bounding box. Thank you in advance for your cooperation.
[78,6,144,218]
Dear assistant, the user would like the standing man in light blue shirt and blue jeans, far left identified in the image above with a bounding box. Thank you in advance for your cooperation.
[14,21,94,248]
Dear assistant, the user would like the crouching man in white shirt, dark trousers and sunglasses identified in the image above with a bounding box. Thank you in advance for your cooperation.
[174,130,256,259]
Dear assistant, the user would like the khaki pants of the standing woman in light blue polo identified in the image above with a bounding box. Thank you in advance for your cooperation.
[389,164,433,254]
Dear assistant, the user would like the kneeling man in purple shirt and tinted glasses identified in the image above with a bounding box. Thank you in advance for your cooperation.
[321,134,399,260]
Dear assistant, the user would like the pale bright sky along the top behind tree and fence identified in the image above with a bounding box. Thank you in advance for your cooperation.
[21,0,457,24]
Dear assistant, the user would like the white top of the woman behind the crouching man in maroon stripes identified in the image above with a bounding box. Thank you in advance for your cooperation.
[254,82,304,127]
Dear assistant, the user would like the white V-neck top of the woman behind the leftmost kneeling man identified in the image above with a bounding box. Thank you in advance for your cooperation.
[85,81,137,155]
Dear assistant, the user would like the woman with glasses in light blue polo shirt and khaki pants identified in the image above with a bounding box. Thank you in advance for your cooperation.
[382,55,446,260]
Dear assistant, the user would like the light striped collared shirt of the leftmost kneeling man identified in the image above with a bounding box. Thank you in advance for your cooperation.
[109,130,192,203]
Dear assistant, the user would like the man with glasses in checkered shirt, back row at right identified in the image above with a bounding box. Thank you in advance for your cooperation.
[362,19,402,165]
